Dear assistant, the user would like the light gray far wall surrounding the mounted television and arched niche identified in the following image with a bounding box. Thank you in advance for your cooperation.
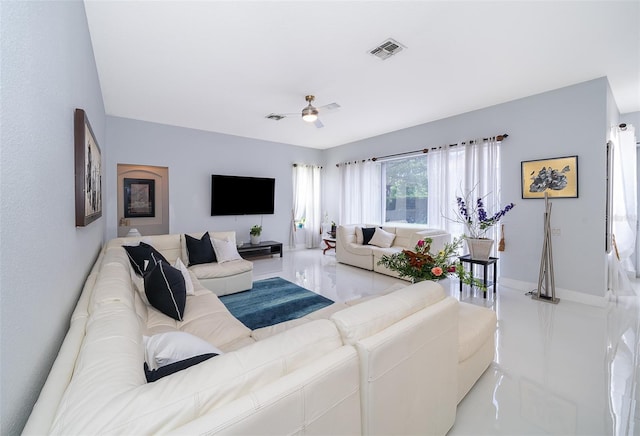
[105,117,322,246]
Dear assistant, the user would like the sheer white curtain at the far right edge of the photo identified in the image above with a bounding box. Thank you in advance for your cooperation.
[610,125,638,277]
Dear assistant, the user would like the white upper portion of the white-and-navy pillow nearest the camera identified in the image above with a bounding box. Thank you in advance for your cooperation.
[143,331,223,370]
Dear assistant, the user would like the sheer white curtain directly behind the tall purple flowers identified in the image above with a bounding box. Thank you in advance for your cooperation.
[427,138,502,250]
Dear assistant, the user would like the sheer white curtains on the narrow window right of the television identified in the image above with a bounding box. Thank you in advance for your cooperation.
[289,164,322,248]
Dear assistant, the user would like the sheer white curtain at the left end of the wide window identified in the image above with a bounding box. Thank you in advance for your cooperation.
[338,160,382,224]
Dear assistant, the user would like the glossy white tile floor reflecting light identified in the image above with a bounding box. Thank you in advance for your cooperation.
[254,249,640,436]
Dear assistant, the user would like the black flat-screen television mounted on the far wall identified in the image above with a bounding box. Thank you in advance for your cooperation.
[211,174,276,216]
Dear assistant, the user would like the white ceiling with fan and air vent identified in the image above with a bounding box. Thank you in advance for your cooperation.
[85,0,640,149]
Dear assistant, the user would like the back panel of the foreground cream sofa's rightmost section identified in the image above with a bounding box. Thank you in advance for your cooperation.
[355,297,458,435]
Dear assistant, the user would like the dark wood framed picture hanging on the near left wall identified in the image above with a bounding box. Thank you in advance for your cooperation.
[73,109,102,227]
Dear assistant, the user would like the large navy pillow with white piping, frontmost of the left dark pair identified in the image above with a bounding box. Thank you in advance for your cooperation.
[144,261,187,321]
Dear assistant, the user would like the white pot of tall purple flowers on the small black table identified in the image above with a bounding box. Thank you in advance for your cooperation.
[456,191,515,261]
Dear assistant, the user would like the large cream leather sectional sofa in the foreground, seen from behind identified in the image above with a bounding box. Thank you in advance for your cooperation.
[24,230,495,435]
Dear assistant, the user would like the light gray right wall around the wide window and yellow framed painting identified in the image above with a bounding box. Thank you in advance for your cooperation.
[325,78,615,296]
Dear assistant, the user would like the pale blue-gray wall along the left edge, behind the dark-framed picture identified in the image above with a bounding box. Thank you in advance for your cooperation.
[0,0,106,435]
